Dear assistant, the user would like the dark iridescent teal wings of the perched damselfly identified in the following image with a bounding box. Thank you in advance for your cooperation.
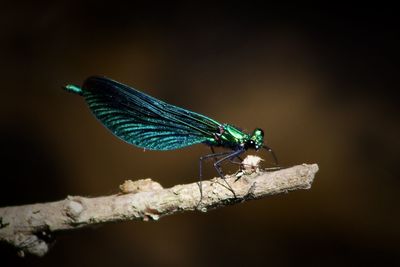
[80,77,221,150]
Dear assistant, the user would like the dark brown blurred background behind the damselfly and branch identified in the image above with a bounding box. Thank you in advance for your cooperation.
[0,0,400,266]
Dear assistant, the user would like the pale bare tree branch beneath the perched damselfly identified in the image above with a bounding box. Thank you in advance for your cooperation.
[0,164,318,256]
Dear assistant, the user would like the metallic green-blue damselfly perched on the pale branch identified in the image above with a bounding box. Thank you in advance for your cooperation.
[64,76,278,199]
